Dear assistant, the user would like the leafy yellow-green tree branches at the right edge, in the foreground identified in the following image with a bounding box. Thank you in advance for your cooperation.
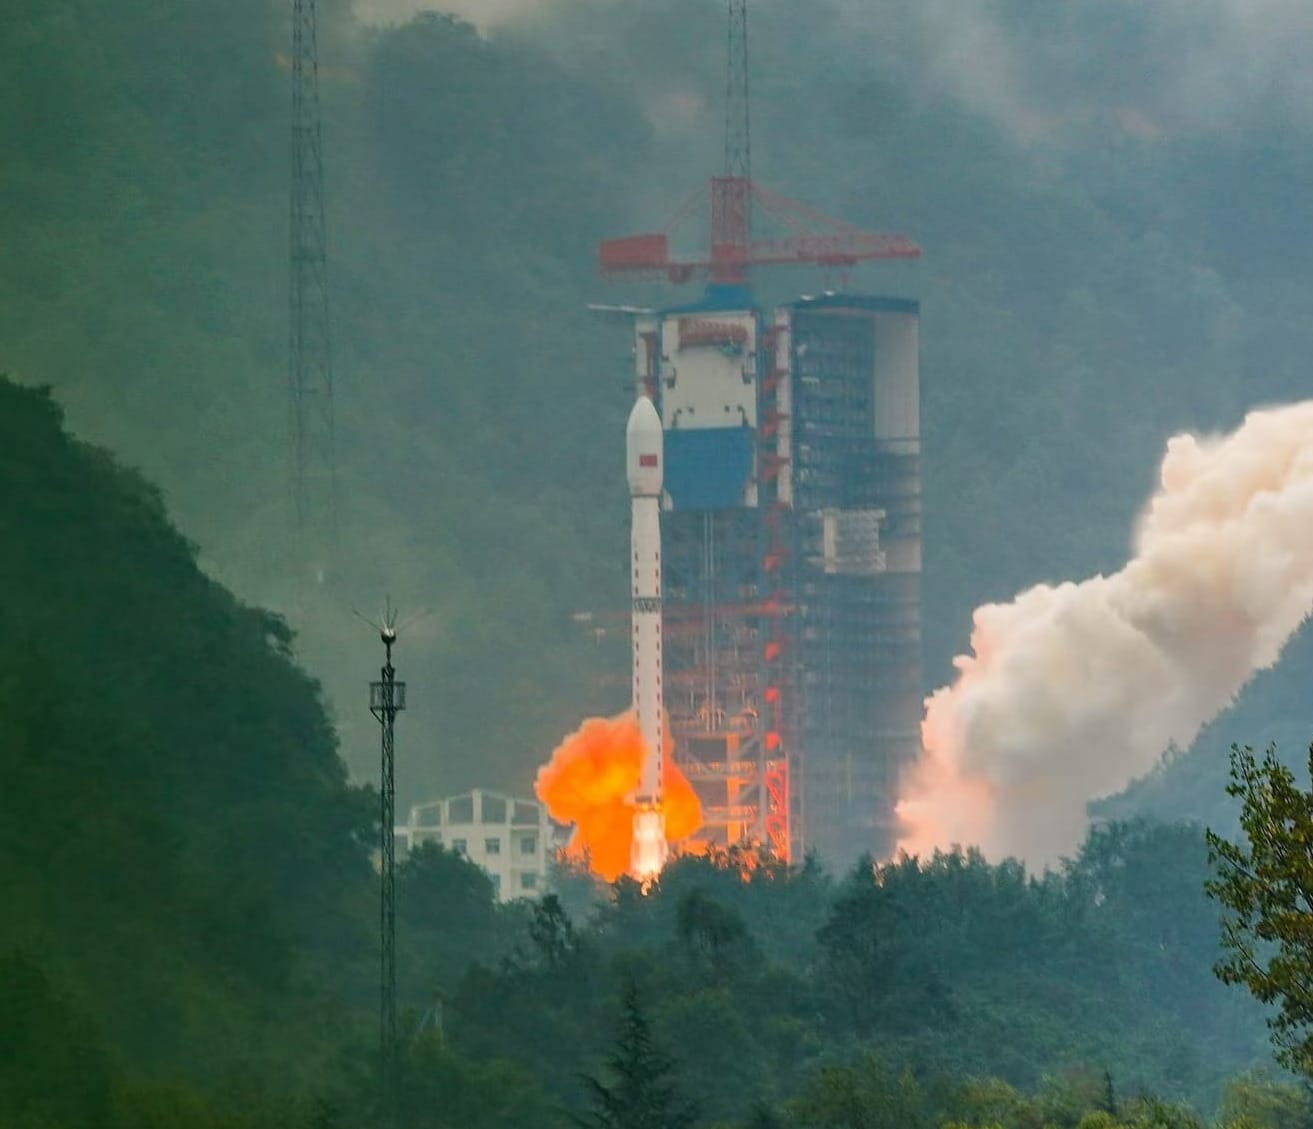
[1207,747,1313,1075]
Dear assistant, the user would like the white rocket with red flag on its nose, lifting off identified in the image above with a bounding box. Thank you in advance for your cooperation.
[625,396,666,882]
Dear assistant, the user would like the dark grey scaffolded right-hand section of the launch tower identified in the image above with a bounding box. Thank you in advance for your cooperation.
[789,295,922,857]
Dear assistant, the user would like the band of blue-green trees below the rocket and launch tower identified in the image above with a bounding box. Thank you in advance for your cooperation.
[448,826,1264,1124]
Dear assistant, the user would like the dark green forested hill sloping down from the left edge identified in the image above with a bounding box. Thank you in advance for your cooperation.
[0,382,370,1079]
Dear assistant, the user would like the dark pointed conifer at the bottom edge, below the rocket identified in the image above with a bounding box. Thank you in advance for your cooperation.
[574,981,697,1129]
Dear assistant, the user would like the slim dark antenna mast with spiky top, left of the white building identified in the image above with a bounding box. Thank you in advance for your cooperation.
[369,607,406,1126]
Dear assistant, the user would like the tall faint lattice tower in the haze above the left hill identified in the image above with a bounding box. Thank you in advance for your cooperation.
[288,0,337,567]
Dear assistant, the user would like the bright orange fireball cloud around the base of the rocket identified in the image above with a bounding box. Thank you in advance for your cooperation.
[533,710,702,882]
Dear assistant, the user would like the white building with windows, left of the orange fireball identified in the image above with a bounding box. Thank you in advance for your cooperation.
[395,788,558,902]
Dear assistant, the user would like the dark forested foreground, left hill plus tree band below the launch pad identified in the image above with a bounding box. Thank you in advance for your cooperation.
[0,382,1281,1129]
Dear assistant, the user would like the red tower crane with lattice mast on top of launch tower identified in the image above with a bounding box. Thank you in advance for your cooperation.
[597,0,920,282]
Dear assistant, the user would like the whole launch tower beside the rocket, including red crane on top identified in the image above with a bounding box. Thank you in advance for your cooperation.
[599,0,920,864]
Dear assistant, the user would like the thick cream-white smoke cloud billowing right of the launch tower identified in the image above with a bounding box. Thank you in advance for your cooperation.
[899,402,1313,864]
